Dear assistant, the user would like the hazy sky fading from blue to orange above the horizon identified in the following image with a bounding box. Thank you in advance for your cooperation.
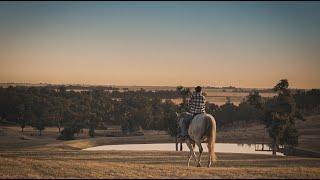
[0,2,320,88]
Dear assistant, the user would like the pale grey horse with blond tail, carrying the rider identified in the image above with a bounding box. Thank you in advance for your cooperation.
[177,112,217,168]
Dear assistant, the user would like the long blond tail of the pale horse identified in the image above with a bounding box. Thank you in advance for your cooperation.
[207,117,217,161]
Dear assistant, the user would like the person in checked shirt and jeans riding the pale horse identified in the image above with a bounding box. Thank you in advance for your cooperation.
[178,86,206,139]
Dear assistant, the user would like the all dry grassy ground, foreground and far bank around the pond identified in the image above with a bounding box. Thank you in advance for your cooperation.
[0,116,320,178]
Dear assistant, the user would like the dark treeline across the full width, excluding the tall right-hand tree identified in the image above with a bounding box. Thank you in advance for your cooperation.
[0,82,320,145]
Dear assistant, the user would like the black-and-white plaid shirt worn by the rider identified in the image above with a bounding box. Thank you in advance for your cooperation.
[189,92,206,114]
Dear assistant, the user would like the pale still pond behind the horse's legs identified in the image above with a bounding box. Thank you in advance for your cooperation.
[83,143,283,156]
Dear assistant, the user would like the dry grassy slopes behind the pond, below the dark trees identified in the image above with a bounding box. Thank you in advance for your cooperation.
[0,115,320,152]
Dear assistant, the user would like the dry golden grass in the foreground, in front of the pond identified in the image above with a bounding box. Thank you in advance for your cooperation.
[0,151,320,178]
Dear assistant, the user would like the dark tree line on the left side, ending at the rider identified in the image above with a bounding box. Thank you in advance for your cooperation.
[0,86,179,139]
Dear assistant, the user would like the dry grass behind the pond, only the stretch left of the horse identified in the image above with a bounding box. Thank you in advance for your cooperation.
[0,126,174,151]
